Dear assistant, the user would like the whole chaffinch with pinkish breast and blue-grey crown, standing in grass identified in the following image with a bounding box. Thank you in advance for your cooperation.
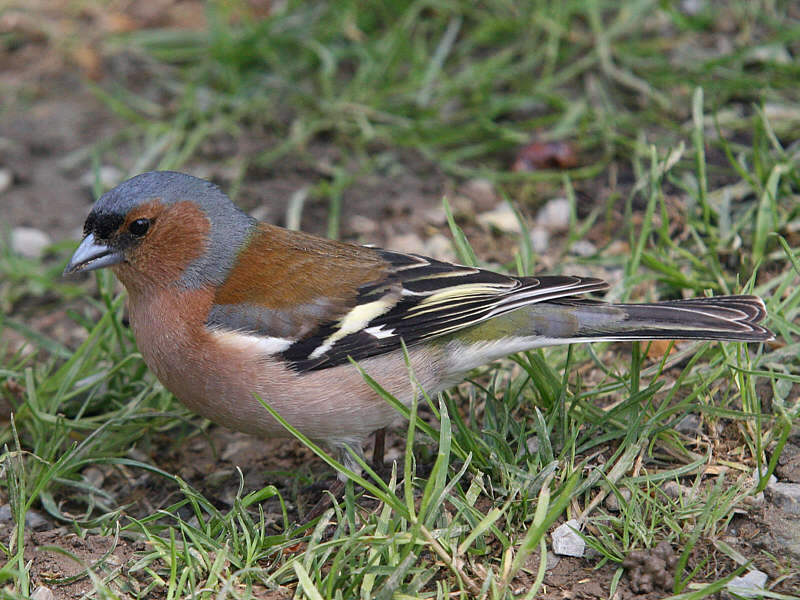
[64,172,772,476]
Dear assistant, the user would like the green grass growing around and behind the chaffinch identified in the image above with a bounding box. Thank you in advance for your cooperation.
[0,0,800,599]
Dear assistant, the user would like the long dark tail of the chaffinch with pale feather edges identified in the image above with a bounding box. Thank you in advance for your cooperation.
[564,296,773,342]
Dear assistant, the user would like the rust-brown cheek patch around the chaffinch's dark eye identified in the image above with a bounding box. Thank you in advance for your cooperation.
[114,200,210,293]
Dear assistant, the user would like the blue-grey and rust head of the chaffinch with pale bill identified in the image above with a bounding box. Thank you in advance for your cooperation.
[64,171,255,290]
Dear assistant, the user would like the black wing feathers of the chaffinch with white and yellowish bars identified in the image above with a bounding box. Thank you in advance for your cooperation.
[283,250,608,370]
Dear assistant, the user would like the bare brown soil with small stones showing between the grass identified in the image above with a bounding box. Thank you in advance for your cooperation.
[0,0,800,599]
